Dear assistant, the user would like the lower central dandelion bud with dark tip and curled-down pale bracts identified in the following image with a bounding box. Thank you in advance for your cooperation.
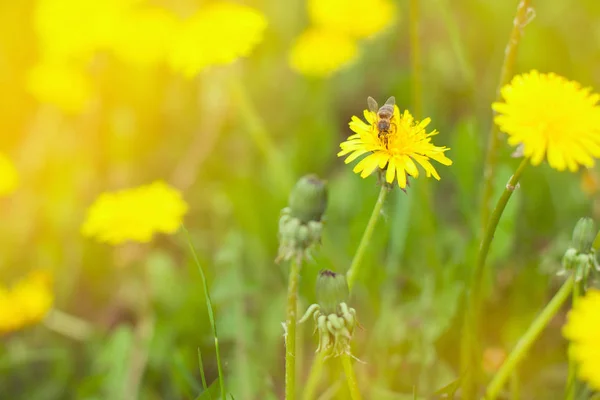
[299,270,360,357]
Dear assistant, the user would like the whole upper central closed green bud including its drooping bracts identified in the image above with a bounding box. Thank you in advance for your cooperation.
[276,175,327,262]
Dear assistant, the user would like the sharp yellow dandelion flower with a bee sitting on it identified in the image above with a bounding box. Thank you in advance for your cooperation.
[338,99,452,189]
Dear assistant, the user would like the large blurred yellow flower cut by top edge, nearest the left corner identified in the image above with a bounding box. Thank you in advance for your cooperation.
[34,0,141,60]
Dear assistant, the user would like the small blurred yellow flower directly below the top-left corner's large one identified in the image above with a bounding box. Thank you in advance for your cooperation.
[27,62,92,114]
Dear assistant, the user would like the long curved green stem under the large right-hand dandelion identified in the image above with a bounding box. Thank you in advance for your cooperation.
[461,157,529,400]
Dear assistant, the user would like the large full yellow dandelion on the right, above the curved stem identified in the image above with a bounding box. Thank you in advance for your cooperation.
[492,70,600,172]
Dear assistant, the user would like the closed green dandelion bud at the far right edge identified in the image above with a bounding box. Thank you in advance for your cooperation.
[558,218,600,282]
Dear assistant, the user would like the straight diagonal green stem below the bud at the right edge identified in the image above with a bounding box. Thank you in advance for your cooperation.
[485,275,574,400]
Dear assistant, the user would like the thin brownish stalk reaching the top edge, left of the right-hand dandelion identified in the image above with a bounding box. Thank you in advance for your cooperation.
[481,0,531,230]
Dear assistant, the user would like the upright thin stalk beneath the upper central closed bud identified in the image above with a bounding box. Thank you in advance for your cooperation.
[285,259,301,400]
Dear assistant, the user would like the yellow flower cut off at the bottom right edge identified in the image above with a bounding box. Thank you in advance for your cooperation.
[563,289,600,390]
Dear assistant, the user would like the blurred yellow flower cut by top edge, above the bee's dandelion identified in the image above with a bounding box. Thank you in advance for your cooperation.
[308,0,396,39]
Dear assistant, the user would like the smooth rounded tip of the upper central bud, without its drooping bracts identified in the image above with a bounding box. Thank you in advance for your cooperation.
[289,174,327,224]
